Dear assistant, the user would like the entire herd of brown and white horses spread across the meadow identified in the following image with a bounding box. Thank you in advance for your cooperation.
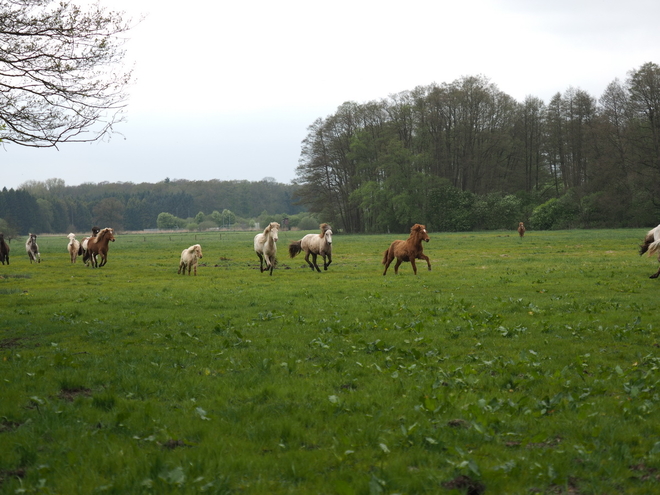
[0,222,660,278]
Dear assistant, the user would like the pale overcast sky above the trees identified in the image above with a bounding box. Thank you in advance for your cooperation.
[0,0,660,188]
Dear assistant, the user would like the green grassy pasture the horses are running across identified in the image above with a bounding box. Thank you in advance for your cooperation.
[0,229,660,494]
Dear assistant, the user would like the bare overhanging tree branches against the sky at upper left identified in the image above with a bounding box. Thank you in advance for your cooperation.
[0,0,131,147]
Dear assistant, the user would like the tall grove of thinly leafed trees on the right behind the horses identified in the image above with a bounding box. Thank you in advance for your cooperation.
[296,63,660,232]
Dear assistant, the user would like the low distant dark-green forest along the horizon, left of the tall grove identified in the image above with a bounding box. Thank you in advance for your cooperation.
[0,179,308,235]
